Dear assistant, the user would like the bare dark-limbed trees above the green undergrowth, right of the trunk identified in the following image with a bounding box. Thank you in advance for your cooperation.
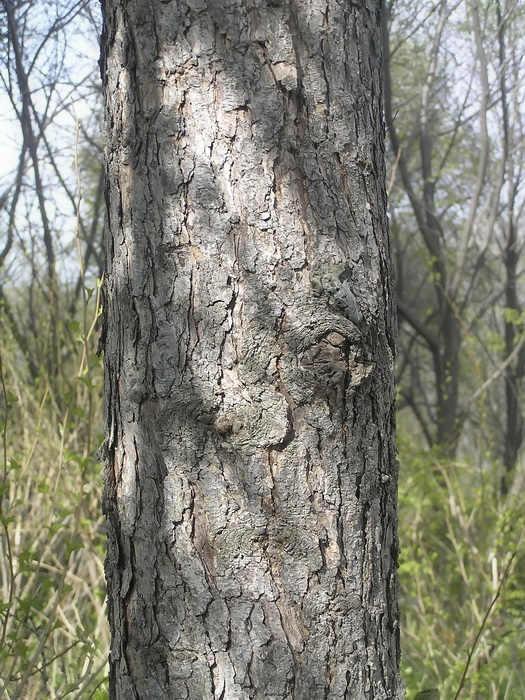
[384,0,524,476]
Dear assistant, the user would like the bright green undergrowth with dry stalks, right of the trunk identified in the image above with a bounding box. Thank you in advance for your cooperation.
[399,437,525,700]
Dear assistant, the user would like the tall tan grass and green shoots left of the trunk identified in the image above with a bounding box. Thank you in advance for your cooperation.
[0,286,108,700]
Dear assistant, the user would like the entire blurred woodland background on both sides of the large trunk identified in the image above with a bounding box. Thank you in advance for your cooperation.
[0,0,525,700]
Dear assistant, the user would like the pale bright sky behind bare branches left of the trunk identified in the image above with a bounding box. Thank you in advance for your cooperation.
[0,0,100,284]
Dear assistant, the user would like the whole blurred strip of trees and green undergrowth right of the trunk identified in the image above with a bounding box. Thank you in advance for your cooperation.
[383,0,524,700]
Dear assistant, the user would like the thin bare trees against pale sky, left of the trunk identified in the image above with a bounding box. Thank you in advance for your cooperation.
[0,0,103,382]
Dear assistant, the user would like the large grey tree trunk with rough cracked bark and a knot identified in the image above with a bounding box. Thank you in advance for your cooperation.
[102,0,401,700]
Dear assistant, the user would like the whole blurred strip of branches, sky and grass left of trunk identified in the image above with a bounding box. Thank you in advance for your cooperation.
[0,0,108,700]
